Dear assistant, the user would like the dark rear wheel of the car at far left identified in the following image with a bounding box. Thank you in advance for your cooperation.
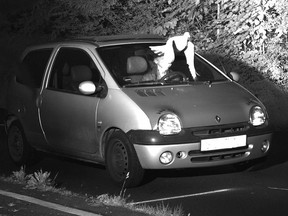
[7,122,35,166]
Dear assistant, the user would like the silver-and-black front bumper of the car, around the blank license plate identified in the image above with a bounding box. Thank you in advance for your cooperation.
[130,125,272,169]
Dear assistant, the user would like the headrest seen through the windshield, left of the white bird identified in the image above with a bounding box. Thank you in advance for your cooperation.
[127,56,148,74]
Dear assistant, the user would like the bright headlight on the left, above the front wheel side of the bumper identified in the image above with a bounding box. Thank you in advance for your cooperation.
[158,113,181,135]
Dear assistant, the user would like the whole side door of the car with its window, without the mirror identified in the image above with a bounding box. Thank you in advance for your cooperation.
[40,47,101,156]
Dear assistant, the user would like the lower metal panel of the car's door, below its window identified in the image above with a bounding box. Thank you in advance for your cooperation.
[40,89,99,155]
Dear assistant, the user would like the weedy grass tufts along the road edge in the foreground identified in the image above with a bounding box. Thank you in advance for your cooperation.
[1,166,190,216]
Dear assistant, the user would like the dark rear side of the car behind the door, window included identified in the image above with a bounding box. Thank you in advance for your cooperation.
[8,47,53,147]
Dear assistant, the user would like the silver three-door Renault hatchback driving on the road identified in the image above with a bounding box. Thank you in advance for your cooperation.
[5,34,272,187]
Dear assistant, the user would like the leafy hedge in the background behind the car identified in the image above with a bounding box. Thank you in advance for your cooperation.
[0,0,288,88]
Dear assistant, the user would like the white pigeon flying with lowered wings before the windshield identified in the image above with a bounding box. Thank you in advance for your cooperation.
[150,32,197,80]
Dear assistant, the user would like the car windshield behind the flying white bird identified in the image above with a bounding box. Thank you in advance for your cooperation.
[97,43,227,87]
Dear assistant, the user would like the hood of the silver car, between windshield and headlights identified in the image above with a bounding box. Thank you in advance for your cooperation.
[123,81,262,128]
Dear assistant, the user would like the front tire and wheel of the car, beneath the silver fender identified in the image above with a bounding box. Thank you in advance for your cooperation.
[105,131,144,188]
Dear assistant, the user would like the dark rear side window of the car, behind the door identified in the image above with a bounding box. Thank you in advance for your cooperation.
[16,48,53,88]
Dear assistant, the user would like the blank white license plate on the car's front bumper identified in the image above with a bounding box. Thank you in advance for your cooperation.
[201,135,246,151]
